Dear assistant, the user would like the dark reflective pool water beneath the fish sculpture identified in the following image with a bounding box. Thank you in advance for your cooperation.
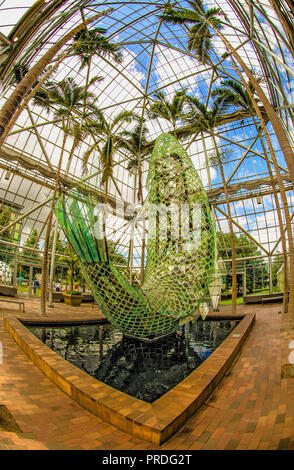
[26,320,238,403]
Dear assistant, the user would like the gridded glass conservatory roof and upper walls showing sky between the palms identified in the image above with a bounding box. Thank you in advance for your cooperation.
[0,0,294,266]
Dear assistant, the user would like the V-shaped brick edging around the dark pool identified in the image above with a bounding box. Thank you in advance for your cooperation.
[3,314,255,445]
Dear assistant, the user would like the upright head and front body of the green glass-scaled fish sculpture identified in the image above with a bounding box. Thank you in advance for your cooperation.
[142,133,214,321]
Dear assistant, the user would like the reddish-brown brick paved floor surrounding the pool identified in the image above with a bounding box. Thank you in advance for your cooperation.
[0,301,294,450]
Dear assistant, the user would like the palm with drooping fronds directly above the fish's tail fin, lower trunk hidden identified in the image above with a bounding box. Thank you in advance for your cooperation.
[83,109,138,203]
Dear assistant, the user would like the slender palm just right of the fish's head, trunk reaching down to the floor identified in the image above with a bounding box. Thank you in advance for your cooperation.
[183,96,237,313]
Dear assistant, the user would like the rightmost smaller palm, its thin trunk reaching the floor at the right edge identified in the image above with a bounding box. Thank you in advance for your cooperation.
[211,80,294,313]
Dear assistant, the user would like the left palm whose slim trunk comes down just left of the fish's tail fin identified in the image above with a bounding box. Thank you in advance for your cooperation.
[34,77,97,315]
